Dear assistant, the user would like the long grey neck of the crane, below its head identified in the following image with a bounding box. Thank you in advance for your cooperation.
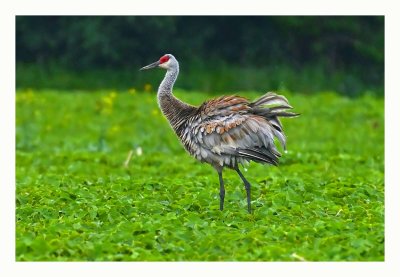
[157,66,194,133]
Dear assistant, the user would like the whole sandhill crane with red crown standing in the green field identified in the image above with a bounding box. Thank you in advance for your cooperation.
[140,54,298,213]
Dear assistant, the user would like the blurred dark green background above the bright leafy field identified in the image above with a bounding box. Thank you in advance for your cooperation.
[16,16,384,96]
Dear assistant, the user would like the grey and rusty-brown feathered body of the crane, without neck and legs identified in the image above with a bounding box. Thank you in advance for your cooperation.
[173,92,298,169]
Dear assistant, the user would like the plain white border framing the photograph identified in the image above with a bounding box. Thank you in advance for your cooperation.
[0,0,400,277]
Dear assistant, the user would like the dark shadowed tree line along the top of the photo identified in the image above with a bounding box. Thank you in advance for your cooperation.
[16,16,384,91]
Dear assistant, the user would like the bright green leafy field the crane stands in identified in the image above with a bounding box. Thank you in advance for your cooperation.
[16,89,384,261]
